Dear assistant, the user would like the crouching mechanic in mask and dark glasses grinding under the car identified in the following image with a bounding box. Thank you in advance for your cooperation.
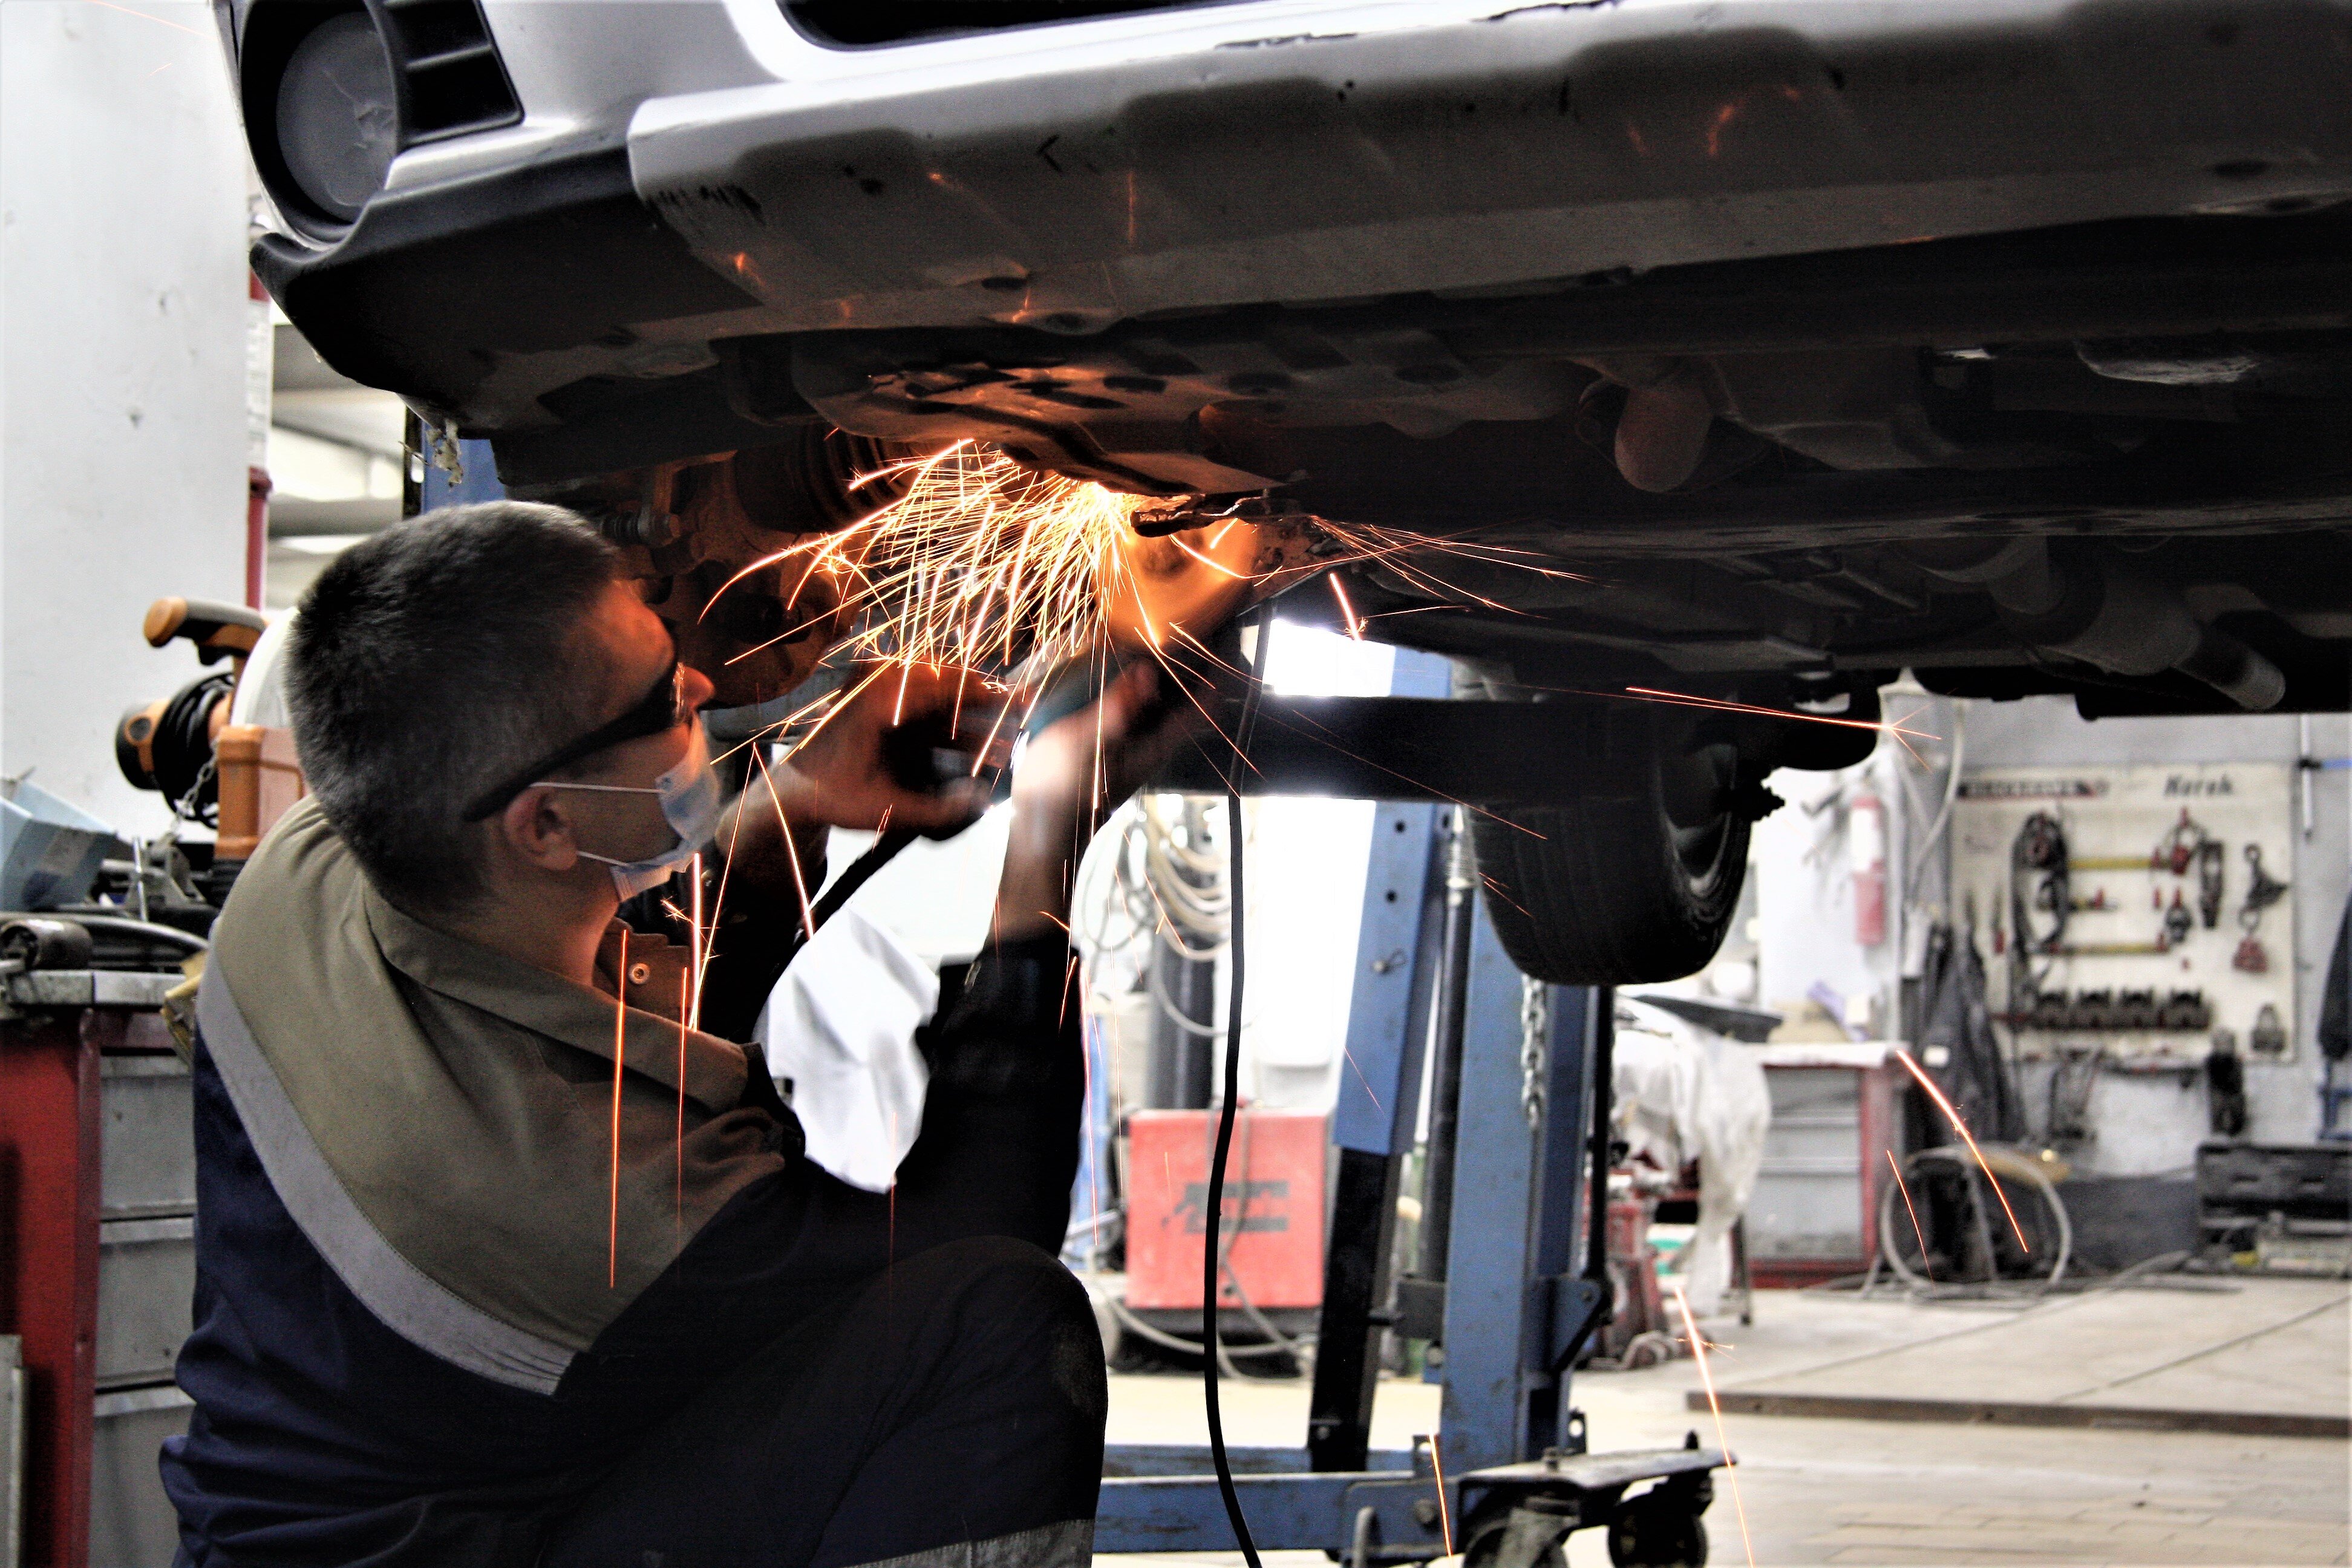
[162,501,1181,1568]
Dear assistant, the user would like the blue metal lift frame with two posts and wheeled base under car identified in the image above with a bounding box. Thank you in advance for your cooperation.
[1094,653,1722,1563]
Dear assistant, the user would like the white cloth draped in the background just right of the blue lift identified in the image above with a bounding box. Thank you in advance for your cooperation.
[1611,997,1771,1316]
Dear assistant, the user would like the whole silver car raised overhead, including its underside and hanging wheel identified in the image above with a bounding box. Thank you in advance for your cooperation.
[230,0,2352,982]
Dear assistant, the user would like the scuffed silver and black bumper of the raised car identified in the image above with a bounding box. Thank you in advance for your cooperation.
[256,0,2352,489]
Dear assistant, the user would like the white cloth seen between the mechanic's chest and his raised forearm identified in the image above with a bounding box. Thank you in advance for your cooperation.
[760,907,938,1192]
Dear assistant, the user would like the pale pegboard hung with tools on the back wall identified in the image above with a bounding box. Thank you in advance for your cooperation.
[1952,762,2296,1060]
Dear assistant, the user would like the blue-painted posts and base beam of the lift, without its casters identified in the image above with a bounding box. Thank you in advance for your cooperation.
[1094,884,1597,1561]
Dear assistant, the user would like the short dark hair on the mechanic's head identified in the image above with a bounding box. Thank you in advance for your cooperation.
[284,501,619,915]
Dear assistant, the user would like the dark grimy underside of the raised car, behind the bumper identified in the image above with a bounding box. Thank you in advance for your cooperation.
[468,212,2352,717]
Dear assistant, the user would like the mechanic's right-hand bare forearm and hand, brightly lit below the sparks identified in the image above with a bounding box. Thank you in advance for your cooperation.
[995,665,1197,942]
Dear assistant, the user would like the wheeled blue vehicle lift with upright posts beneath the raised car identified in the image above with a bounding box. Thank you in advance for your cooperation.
[1094,653,1726,1568]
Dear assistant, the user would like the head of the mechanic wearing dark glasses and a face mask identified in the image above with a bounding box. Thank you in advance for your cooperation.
[287,501,710,924]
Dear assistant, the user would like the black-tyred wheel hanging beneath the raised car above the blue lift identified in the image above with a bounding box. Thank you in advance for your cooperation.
[1470,703,1757,985]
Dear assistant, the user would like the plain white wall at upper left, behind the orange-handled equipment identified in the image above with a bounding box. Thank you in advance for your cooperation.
[0,0,247,832]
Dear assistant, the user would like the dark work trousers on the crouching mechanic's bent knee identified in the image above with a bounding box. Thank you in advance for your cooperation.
[541,1236,1108,1568]
